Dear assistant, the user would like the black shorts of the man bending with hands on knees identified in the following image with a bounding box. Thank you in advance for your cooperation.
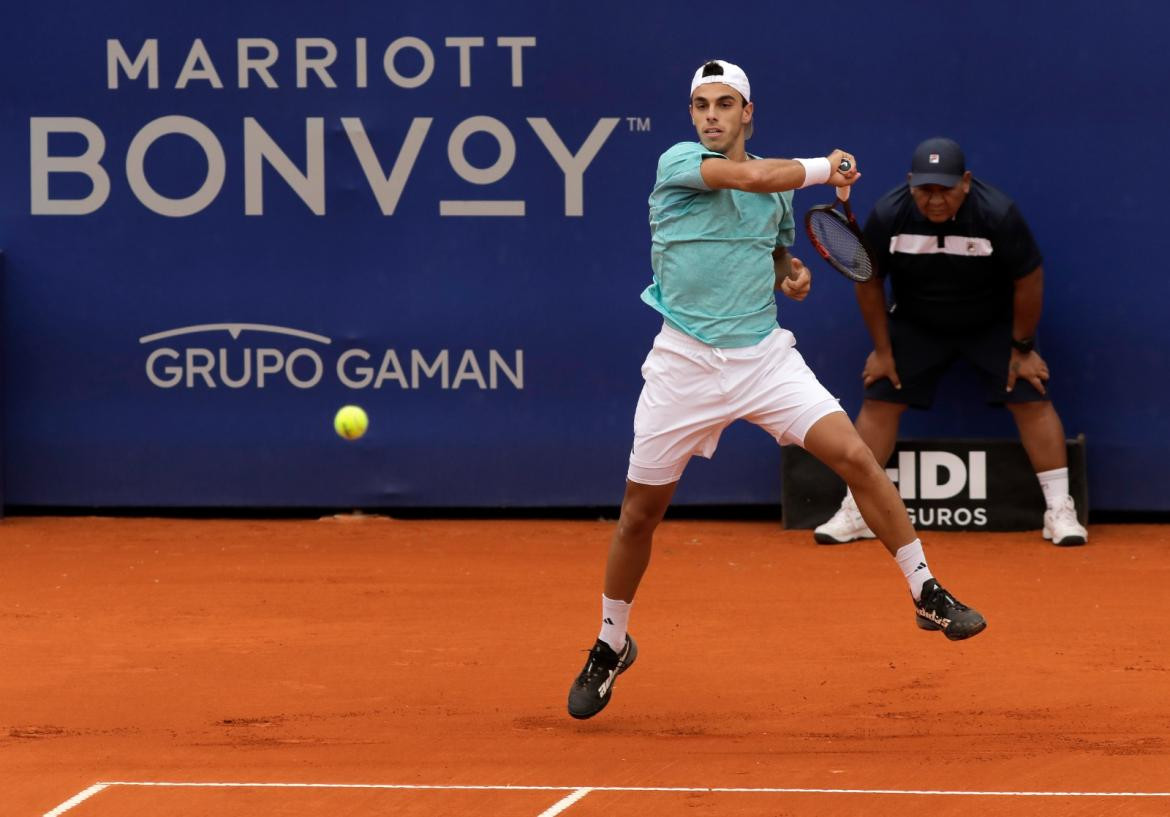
[866,317,1048,409]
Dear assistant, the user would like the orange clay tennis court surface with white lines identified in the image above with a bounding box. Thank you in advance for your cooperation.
[0,517,1170,817]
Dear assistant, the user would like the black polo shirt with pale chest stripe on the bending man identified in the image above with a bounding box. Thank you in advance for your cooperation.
[865,178,1042,334]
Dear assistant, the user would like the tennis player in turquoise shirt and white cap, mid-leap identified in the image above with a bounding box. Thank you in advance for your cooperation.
[569,60,986,719]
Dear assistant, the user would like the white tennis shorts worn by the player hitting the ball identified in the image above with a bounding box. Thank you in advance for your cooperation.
[627,325,842,485]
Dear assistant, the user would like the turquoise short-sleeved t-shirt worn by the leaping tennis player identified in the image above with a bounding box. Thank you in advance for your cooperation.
[642,142,796,349]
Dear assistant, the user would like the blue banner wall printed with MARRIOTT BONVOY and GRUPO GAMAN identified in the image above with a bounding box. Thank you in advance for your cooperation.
[0,0,1170,510]
